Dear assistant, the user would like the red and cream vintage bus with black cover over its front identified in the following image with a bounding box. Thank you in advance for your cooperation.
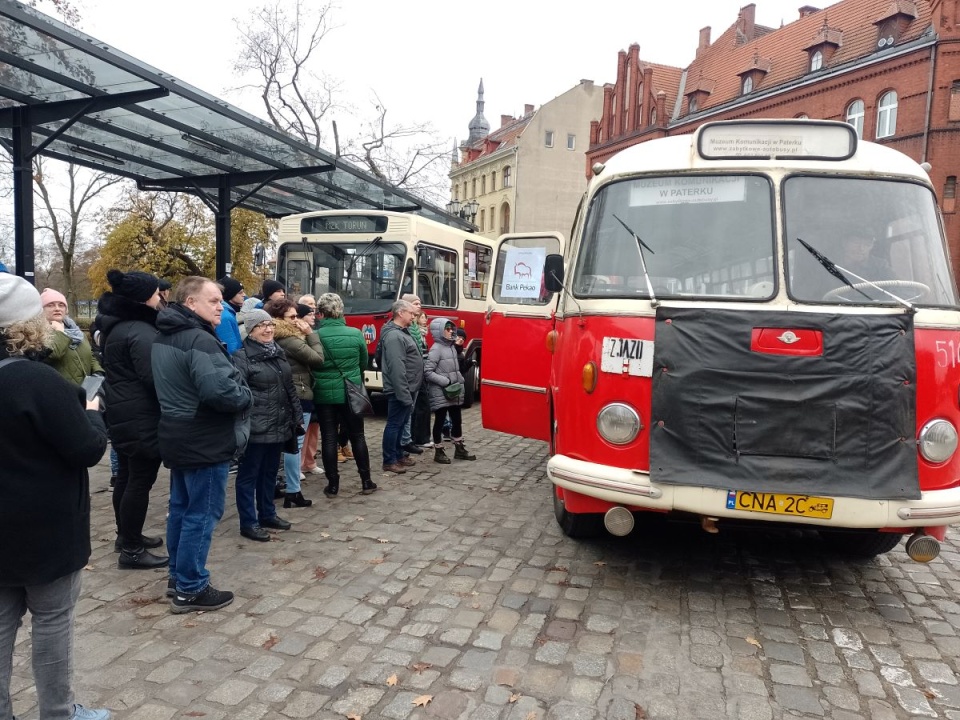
[482,120,960,561]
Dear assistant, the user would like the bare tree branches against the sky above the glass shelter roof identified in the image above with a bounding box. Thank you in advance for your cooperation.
[234,0,450,203]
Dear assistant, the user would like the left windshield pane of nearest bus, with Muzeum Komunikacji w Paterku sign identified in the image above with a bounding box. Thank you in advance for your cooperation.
[573,175,775,300]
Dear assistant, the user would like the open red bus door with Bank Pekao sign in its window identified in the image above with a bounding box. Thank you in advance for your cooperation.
[480,233,563,441]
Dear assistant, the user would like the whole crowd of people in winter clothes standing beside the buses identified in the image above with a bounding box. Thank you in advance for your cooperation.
[0,270,476,720]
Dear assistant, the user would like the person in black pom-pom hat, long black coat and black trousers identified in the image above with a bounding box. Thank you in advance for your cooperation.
[97,270,168,570]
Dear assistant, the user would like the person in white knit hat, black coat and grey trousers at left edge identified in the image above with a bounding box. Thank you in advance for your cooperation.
[0,274,110,720]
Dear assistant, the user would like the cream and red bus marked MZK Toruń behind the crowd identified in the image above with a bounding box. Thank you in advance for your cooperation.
[277,210,493,405]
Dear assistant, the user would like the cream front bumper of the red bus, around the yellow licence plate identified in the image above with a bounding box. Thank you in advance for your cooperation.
[547,455,960,530]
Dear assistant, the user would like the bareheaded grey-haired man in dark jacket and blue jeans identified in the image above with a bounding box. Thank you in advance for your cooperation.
[151,277,253,613]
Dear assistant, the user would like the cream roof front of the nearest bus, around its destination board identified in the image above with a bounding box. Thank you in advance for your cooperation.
[591,134,930,185]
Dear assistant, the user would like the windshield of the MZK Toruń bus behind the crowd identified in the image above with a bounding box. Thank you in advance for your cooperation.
[277,242,407,315]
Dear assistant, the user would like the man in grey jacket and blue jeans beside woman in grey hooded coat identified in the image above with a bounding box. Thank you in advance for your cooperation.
[380,300,423,473]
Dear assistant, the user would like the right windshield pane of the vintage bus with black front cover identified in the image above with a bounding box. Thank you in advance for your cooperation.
[783,175,957,306]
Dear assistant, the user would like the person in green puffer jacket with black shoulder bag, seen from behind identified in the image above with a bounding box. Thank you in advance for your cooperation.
[313,293,377,498]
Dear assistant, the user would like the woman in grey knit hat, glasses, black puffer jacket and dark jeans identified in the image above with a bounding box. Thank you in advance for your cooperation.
[233,309,303,542]
